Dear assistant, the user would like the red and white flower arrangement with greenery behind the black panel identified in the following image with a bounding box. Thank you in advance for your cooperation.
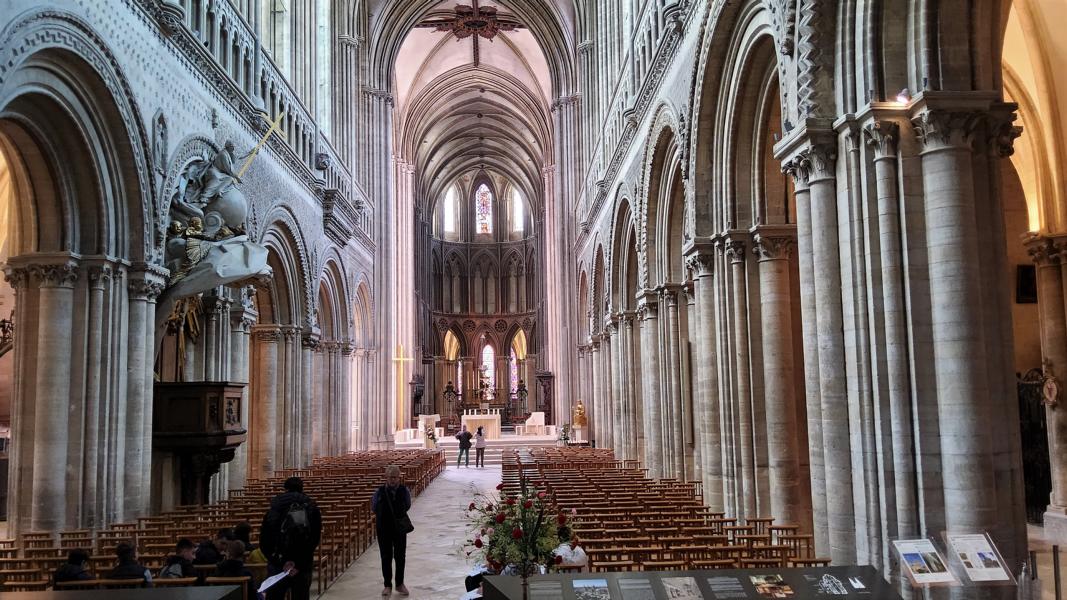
[464,474,573,582]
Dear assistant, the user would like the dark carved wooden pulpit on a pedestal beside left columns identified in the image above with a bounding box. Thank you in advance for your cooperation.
[152,381,245,504]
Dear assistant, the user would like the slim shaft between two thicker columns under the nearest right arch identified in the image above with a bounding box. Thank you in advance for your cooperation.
[723,232,759,518]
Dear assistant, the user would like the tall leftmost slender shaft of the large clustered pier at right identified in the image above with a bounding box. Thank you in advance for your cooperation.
[783,154,830,556]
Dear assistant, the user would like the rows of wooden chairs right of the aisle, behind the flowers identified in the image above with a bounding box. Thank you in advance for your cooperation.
[503,447,829,571]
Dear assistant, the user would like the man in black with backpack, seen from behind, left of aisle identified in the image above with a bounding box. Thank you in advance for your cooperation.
[259,477,322,600]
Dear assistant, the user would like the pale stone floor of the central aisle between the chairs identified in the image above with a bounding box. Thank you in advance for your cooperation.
[322,467,500,600]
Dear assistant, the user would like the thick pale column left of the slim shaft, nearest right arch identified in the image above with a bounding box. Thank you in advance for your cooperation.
[686,247,726,511]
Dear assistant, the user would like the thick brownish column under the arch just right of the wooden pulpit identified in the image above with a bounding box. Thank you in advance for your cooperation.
[249,325,283,478]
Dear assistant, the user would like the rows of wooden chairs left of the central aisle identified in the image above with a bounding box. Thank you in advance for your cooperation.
[0,449,445,594]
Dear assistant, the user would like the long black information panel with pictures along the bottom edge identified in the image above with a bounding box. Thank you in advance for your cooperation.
[484,567,901,600]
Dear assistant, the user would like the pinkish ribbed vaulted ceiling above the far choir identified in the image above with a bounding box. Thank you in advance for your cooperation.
[393,0,554,210]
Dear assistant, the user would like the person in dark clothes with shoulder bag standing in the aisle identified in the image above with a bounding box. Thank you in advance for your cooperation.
[370,463,411,596]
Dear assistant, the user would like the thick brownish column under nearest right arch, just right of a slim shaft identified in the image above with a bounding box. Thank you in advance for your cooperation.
[753,225,807,524]
